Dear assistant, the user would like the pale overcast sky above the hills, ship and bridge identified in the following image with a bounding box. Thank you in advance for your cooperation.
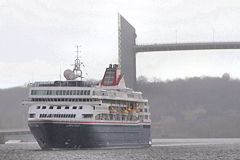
[0,0,240,88]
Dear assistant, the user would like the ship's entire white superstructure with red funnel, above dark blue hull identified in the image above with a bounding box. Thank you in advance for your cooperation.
[25,61,151,123]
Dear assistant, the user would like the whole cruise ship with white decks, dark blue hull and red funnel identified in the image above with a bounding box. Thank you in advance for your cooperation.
[23,52,151,149]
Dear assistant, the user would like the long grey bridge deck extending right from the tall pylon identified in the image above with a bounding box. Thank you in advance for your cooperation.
[135,42,240,53]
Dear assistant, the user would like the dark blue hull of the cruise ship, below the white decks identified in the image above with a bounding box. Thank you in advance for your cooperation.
[29,122,151,149]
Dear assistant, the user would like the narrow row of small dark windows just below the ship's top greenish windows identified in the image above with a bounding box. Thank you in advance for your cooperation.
[32,98,97,102]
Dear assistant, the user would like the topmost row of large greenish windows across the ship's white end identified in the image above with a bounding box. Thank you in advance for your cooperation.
[31,90,90,95]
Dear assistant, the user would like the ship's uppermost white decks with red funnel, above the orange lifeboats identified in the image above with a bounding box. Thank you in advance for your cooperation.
[26,64,147,104]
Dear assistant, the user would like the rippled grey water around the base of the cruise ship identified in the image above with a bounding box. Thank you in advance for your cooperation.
[0,139,240,160]
